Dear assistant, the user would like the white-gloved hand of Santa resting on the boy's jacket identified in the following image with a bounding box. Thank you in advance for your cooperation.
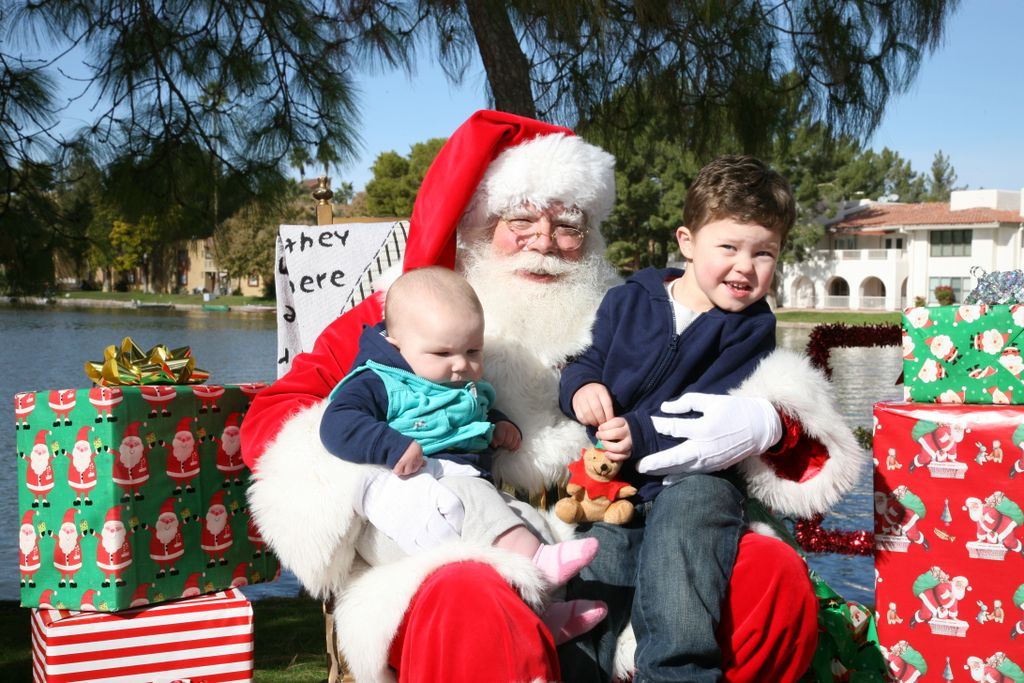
[637,393,782,483]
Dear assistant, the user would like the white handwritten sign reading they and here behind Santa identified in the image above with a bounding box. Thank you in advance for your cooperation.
[275,220,408,377]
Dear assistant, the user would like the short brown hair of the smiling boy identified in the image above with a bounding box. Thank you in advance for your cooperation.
[683,155,797,242]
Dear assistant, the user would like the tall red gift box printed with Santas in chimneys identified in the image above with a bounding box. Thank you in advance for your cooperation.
[873,402,1024,683]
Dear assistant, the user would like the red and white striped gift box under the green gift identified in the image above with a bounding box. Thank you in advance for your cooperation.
[32,589,253,683]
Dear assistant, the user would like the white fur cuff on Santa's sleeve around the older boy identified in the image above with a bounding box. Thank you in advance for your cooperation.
[732,349,868,518]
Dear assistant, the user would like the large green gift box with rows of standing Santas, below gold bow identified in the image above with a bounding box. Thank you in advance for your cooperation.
[14,383,280,611]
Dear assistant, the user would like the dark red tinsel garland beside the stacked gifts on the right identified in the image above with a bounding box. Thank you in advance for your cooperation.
[794,323,901,555]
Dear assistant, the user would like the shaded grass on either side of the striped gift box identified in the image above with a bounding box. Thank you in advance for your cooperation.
[0,597,327,683]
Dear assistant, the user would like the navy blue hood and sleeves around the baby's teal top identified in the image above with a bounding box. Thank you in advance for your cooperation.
[319,323,508,475]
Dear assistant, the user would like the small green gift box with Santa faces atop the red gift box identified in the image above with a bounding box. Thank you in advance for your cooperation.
[903,304,1024,405]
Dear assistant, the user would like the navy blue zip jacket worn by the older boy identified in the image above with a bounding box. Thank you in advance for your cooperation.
[559,268,775,499]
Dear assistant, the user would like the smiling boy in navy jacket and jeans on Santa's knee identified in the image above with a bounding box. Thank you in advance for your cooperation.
[559,156,796,680]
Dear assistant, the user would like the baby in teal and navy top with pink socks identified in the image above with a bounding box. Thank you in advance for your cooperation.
[321,267,606,643]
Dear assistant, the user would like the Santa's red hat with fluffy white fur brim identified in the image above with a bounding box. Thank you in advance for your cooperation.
[403,110,615,271]
